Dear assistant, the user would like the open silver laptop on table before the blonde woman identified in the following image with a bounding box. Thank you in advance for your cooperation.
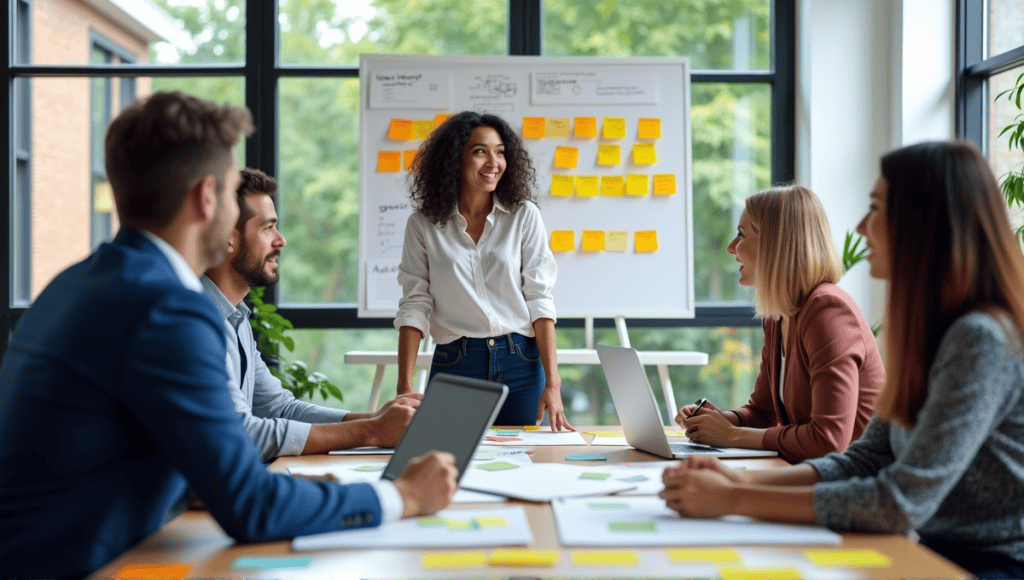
[597,344,778,458]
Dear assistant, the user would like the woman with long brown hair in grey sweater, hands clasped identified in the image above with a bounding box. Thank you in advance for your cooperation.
[662,142,1024,578]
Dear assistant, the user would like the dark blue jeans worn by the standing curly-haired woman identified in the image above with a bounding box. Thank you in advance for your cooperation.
[430,332,544,425]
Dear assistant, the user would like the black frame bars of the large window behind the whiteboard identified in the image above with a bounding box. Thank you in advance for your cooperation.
[0,0,797,353]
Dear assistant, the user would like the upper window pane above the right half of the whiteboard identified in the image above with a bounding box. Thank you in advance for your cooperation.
[543,0,771,71]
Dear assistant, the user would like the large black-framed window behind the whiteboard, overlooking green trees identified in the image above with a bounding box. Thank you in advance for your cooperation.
[0,0,796,423]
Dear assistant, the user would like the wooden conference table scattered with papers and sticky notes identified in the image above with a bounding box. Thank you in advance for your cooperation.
[91,426,969,580]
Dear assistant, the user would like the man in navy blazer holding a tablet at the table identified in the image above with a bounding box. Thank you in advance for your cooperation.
[0,92,456,578]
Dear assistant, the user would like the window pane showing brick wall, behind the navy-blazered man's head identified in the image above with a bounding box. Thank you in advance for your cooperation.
[13,78,243,303]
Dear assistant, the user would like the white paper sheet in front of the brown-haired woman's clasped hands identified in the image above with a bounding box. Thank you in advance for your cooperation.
[551,496,843,546]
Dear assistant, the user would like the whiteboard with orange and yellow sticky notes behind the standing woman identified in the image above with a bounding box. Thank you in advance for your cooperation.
[358,54,694,318]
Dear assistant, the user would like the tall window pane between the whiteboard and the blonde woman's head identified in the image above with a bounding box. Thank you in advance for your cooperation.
[690,84,771,302]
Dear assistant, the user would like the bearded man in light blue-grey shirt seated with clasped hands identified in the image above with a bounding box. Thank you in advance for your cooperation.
[202,168,423,461]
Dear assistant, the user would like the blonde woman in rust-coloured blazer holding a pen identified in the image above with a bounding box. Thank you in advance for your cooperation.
[676,185,885,462]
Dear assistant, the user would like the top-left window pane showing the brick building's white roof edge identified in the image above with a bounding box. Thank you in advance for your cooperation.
[26,0,246,65]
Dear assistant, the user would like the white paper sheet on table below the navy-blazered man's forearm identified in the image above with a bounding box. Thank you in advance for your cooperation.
[292,505,534,550]
